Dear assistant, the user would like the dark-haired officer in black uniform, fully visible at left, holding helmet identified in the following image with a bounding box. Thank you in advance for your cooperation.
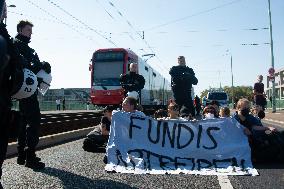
[14,20,45,169]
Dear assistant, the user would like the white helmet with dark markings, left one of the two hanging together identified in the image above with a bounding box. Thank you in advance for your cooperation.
[12,68,38,99]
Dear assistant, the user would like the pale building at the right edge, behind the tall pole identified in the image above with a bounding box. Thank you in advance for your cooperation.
[265,68,284,100]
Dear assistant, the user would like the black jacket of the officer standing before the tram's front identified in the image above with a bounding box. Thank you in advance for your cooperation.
[119,72,145,92]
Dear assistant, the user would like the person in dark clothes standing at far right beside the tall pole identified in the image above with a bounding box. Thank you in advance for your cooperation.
[253,75,266,110]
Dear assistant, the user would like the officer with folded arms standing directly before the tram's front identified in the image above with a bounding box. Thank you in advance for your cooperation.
[120,63,145,101]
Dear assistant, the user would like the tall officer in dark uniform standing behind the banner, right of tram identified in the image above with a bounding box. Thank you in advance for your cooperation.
[169,56,198,116]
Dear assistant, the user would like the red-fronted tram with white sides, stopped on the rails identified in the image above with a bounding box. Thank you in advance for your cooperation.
[90,48,172,106]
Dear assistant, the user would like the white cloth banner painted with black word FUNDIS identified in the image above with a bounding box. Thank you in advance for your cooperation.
[105,112,258,176]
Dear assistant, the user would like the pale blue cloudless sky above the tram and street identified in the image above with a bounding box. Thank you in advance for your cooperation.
[6,0,284,94]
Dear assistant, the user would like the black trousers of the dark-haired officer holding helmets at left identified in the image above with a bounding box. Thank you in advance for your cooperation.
[18,97,40,151]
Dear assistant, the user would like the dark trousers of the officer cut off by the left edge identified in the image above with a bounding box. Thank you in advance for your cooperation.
[0,107,10,179]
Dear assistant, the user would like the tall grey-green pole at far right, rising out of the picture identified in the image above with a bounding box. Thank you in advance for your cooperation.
[268,0,276,113]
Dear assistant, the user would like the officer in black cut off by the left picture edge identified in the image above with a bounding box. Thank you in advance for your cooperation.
[0,0,28,188]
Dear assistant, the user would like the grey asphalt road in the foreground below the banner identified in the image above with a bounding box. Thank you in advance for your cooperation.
[2,137,284,189]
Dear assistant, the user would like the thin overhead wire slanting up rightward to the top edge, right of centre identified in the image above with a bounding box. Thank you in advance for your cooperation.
[145,0,242,31]
